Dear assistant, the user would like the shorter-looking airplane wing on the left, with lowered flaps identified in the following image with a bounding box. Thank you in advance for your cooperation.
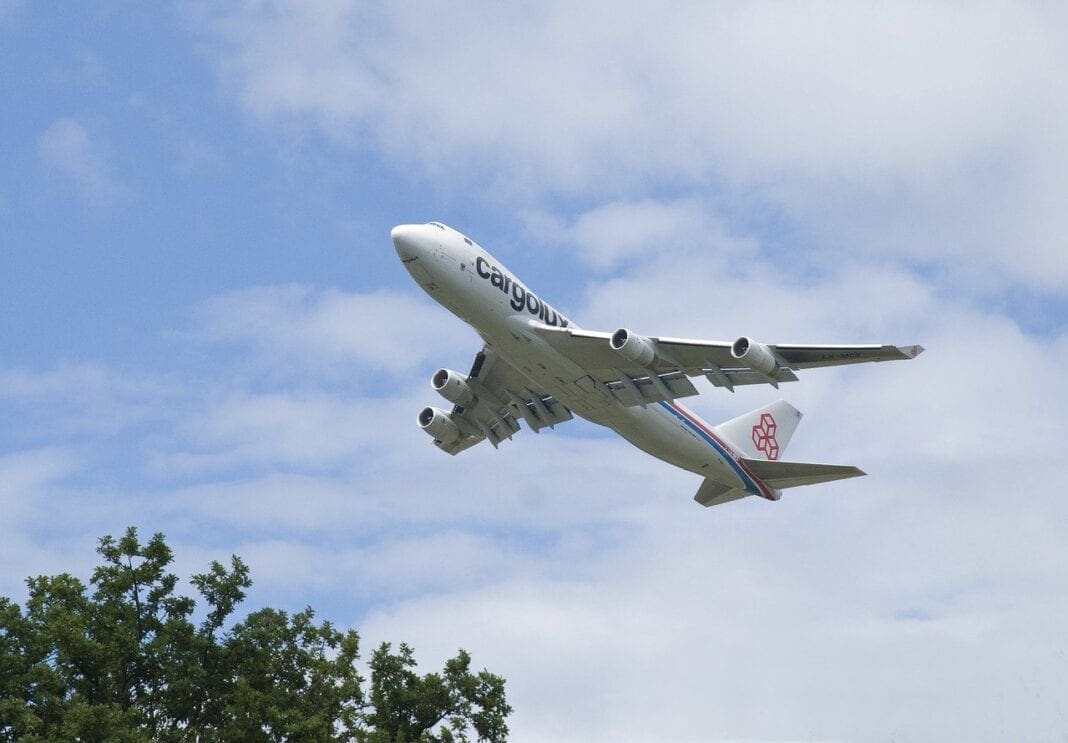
[434,346,572,455]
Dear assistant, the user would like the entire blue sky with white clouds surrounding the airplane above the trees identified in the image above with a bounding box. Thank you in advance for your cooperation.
[0,0,1068,741]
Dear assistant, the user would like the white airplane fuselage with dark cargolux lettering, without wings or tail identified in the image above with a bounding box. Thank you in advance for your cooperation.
[392,222,774,497]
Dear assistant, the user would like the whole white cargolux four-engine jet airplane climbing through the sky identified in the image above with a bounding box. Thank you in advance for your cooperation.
[391,222,924,507]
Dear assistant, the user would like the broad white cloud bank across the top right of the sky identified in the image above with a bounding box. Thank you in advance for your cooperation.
[206,2,1068,293]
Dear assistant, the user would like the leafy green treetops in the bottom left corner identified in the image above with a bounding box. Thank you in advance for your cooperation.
[0,527,512,743]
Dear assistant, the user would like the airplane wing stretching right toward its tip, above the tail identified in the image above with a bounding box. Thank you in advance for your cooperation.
[533,323,924,397]
